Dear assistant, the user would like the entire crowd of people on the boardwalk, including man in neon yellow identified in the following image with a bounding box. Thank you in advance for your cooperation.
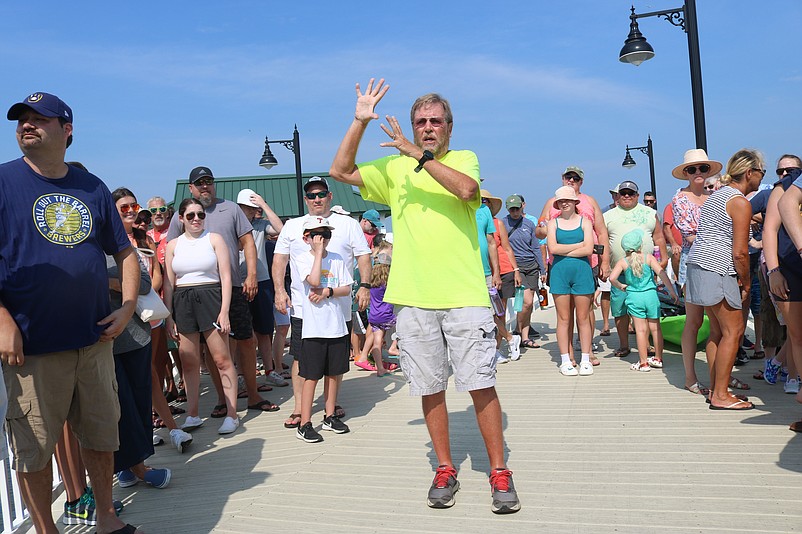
[0,86,802,534]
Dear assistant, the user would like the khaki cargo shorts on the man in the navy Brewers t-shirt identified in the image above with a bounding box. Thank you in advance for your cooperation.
[3,342,120,473]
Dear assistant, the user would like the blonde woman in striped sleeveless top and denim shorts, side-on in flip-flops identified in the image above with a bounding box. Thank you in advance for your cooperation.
[686,149,766,410]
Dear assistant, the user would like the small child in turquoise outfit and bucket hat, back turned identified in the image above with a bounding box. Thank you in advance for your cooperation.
[610,229,679,371]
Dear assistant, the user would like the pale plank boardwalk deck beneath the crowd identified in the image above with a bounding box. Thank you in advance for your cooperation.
[39,309,802,534]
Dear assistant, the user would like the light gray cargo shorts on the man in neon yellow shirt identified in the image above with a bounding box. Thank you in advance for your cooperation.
[395,306,496,395]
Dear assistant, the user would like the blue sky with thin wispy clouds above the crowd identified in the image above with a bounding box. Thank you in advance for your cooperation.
[0,0,802,213]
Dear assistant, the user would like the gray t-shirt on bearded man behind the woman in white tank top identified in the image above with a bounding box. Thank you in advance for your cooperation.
[167,198,253,287]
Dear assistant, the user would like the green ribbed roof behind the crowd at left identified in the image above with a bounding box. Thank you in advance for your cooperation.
[173,173,390,218]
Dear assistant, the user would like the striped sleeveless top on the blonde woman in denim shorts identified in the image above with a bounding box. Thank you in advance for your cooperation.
[688,186,751,276]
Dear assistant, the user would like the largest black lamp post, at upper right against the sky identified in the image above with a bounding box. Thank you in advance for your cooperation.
[618,0,707,151]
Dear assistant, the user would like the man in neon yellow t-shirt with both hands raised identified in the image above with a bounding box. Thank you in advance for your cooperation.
[329,79,521,513]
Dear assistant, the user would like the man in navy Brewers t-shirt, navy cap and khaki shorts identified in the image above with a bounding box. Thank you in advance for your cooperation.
[0,93,139,533]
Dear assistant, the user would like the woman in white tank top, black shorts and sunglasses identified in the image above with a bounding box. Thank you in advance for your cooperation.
[164,198,239,434]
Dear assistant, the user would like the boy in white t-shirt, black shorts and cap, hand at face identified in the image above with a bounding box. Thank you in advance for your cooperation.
[297,216,353,443]
